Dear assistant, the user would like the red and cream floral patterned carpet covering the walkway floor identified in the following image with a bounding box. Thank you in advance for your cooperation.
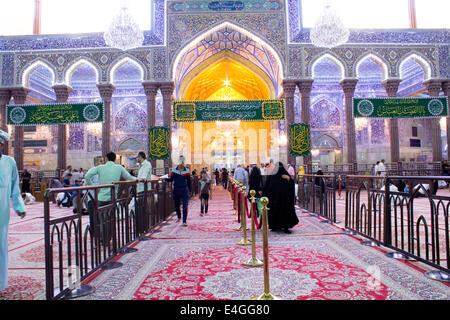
[0,188,450,300]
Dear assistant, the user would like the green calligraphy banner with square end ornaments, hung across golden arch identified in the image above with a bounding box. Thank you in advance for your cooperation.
[173,99,285,122]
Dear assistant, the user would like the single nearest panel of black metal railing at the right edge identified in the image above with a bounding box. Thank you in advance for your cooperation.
[383,176,450,272]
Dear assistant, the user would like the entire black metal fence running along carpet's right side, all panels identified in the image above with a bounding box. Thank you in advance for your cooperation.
[297,169,450,281]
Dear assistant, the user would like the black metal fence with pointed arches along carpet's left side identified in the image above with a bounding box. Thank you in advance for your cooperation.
[44,181,174,299]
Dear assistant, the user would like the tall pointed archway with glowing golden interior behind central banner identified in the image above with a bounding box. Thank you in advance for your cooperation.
[172,23,282,169]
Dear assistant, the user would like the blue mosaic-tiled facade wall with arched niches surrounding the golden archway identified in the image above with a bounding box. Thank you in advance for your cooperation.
[0,0,450,165]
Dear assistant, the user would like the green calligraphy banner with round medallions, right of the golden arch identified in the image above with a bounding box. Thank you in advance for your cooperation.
[353,97,448,119]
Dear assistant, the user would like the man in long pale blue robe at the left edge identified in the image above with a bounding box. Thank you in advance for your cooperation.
[0,130,26,290]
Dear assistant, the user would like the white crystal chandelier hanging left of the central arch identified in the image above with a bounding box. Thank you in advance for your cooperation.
[103,6,144,50]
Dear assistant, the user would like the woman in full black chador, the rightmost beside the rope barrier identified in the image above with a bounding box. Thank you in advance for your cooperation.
[263,162,298,233]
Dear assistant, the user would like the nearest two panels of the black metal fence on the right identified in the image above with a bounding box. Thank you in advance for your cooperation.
[345,172,450,274]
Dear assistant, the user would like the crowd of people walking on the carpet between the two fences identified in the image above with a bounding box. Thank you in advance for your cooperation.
[158,156,298,233]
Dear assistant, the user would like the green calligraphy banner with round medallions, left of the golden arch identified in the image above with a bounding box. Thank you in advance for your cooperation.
[6,102,104,126]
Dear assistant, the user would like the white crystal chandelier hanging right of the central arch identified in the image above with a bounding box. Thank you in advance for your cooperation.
[310,1,350,48]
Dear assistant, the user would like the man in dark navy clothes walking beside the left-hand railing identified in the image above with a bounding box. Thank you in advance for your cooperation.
[166,156,191,227]
